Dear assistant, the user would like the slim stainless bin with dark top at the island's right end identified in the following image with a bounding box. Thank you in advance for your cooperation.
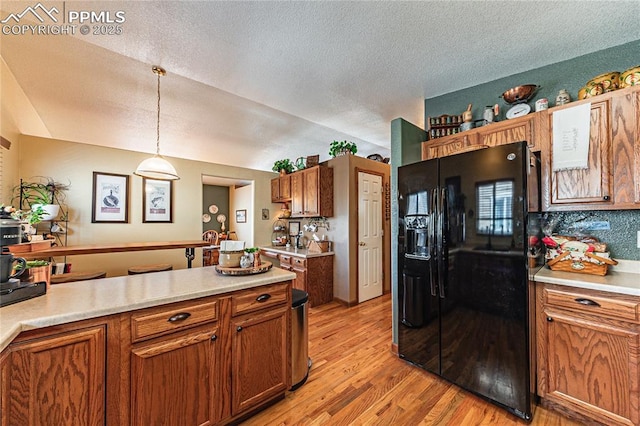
[291,288,311,391]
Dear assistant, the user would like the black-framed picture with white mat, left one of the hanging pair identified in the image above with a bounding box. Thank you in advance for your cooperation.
[91,172,129,223]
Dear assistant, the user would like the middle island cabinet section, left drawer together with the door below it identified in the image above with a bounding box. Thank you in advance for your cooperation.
[130,299,223,425]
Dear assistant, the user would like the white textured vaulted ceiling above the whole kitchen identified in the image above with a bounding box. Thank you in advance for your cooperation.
[0,0,640,170]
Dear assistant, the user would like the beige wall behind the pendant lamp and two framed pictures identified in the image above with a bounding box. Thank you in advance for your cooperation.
[8,135,278,276]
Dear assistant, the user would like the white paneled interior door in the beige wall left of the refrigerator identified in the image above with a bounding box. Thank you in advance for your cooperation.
[358,172,383,302]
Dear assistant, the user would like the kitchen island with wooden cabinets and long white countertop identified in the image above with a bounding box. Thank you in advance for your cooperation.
[0,267,295,425]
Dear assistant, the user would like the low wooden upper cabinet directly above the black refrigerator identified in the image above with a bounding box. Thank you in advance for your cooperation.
[422,113,542,160]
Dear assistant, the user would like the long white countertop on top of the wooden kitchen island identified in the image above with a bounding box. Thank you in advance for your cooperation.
[0,266,296,351]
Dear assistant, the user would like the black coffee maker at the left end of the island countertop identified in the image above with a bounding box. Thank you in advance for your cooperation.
[0,208,47,307]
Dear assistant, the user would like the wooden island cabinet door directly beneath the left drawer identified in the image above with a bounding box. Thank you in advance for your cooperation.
[131,327,221,425]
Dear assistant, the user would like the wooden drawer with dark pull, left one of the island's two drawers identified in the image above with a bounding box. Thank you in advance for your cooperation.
[131,300,218,342]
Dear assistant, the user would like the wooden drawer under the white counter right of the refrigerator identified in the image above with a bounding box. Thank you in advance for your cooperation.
[545,288,640,322]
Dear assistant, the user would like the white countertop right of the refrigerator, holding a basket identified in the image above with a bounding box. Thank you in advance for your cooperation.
[534,260,640,296]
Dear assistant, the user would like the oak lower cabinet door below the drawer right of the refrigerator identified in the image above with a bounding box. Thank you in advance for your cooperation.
[538,307,640,425]
